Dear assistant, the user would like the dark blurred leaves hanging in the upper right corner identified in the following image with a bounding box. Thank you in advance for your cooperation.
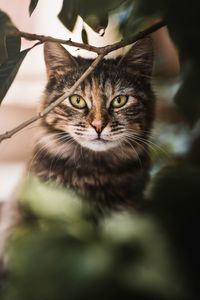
[136,0,200,124]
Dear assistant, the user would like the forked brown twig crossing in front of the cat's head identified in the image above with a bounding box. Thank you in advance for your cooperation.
[0,21,166,143]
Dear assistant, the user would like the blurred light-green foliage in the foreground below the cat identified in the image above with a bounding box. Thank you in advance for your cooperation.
[1,178,187,300]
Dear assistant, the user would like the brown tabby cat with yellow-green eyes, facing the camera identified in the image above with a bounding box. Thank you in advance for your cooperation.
[31,37,155,210]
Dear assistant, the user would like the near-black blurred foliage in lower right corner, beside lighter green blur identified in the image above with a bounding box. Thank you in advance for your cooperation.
[150,160,200,299]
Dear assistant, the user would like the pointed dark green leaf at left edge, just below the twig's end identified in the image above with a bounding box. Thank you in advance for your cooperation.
[0,48,32,103]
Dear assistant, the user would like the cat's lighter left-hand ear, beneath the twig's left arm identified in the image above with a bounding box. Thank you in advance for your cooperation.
[44,42,77,75]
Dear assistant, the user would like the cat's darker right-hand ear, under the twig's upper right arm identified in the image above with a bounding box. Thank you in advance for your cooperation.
[119,37,154,78]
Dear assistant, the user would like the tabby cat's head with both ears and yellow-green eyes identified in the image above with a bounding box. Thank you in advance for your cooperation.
[40,39,154,156]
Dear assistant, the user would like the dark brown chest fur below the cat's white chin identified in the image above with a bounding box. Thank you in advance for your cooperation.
[32,147,149,208]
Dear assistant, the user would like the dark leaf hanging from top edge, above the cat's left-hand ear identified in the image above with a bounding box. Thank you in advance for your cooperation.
[58,0,78,31]
